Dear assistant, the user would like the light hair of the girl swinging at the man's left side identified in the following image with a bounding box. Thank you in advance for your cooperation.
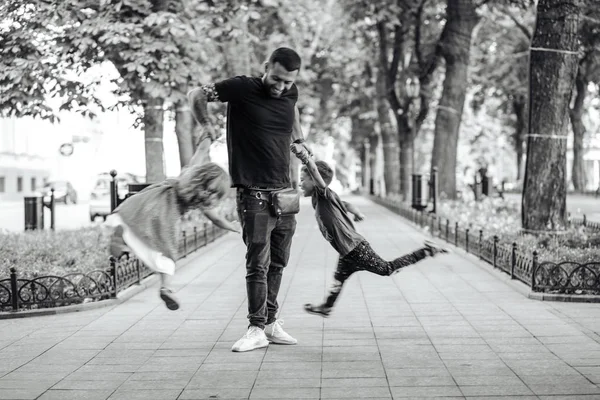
[177,163,230,208]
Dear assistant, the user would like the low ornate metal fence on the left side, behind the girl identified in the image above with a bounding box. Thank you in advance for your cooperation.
[0,222,232,312]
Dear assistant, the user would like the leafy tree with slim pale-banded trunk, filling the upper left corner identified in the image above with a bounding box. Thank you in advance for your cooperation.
[0,0,211,182]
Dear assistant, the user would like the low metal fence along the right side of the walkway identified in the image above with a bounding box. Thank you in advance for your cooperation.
[371,196,600,294]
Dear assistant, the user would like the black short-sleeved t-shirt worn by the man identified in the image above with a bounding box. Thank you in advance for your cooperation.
[212,76,298,189]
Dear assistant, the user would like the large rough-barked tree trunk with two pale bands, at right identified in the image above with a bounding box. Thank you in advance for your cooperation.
[521,0,582,233]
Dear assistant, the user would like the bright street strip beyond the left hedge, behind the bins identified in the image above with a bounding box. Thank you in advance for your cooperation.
[0,202,101,232]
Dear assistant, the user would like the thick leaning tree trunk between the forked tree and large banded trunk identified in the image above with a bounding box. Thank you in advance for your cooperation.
[431,0,479,199]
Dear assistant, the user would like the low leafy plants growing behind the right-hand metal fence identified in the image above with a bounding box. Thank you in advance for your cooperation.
[438,198,600,263]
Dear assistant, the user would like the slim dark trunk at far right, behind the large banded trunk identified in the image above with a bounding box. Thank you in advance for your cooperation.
[570,69,587,192]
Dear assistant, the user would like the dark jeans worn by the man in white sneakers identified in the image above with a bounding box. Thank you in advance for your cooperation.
[237,193,296,329]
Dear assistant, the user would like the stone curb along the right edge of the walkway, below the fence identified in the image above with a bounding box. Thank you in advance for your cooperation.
[368,198,600,303]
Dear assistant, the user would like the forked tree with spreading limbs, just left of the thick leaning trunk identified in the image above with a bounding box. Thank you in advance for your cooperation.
[344,0,443,199]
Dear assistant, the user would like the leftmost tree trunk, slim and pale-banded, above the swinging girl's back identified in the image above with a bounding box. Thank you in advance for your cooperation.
[144,99,165,183]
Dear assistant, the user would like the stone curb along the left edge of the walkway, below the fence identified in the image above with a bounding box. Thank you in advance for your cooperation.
[0,232,228,320]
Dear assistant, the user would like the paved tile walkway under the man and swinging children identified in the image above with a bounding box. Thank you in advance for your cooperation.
[0,198,600,400]
